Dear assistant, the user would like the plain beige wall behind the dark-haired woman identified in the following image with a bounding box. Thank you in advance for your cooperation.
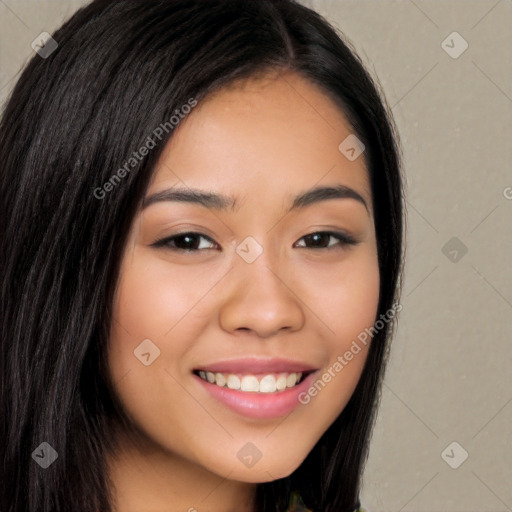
[0,0,512,512]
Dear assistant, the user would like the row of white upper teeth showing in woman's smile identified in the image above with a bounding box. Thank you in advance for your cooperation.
[199,370,302,393]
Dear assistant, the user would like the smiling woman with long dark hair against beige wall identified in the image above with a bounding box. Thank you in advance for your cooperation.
[0,0,403,512]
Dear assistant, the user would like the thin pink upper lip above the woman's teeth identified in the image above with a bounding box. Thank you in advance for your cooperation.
[195,358,316,373]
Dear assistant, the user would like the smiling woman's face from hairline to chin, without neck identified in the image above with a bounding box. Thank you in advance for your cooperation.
[108,73,379,482]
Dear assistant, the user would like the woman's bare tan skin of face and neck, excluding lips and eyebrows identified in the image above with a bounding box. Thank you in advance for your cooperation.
[108,72,379,512]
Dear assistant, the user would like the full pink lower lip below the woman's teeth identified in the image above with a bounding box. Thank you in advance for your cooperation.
[194,372,316,419]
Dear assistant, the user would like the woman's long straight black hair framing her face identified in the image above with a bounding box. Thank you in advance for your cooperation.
[0,0,404,512]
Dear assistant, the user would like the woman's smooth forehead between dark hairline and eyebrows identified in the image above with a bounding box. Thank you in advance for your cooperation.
[149,72,371,212]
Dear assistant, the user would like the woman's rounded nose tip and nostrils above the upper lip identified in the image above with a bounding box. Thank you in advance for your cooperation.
[219,253,305,338]
